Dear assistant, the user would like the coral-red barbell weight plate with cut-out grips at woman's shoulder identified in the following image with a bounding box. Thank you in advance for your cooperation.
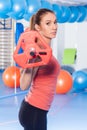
[13,31,52,68]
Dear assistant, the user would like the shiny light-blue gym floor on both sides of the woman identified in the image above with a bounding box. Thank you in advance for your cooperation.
[0,72,87,130]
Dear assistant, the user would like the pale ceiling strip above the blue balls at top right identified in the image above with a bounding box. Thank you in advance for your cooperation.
[48,0,87,6]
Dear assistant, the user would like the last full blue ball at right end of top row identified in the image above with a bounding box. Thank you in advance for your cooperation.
[77,6,87,22]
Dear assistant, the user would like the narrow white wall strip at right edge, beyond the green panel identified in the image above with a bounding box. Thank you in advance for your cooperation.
[76,22,87,69]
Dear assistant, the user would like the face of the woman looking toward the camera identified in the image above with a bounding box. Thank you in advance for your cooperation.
[38,13,58,43]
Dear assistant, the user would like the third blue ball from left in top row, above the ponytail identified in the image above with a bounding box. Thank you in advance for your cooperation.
[24,0,41,21]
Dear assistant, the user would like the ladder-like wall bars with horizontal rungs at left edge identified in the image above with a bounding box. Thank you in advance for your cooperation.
[0,18,14,70]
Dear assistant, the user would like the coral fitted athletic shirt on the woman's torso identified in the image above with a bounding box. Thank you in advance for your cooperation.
[25,56,60,110]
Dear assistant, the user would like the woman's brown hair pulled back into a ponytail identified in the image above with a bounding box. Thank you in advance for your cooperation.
[29,8,54,30]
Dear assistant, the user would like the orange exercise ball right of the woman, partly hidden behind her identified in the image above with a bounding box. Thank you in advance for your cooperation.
[56,69,73,94]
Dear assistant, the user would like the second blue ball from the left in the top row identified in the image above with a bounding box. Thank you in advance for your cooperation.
[8,0,27,20]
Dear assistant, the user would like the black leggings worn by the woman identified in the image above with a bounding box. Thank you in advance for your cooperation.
[19,100,47,130]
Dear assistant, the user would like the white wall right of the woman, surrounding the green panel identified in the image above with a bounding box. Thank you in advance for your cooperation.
[53,22,87,70]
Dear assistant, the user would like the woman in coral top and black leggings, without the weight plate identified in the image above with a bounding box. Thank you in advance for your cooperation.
[19,9,60,130]
